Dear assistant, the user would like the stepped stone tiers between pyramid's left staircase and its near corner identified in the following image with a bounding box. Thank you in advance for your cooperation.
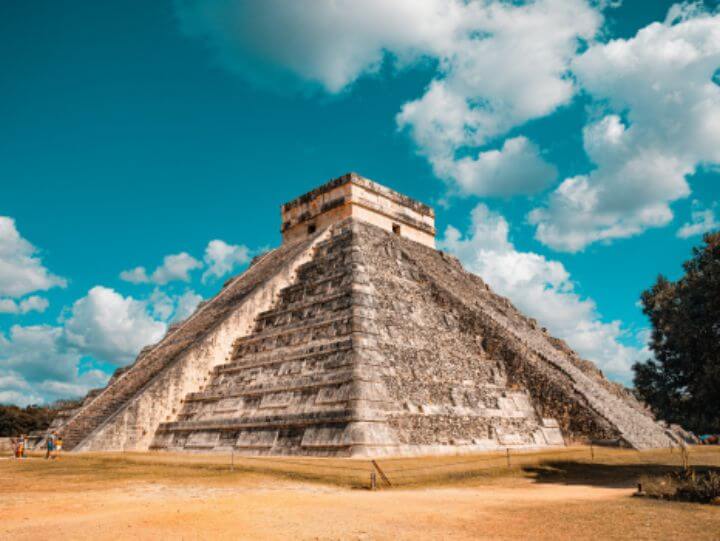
[152,221,376,455]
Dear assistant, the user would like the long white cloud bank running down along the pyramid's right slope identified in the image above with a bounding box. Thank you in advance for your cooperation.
[440,204,647,383]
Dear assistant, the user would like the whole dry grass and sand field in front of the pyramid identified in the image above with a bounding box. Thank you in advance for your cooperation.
[0,447,720,540]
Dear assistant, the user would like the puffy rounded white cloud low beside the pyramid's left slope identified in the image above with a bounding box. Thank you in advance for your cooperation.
[63,286,167,366]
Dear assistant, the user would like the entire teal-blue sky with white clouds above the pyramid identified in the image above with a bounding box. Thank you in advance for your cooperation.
[0,0,720,404]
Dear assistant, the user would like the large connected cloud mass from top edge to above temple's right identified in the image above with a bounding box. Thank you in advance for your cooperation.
[177,0,603,195]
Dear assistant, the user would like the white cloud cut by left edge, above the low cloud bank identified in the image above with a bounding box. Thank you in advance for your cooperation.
[0,216,67,298]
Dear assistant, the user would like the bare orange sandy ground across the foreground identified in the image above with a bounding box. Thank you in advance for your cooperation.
[0,457,720,540]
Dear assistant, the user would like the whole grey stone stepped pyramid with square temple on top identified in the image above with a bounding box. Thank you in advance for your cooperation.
[57,174,679,456]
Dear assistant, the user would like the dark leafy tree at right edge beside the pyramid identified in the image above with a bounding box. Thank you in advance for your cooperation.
[633,231,720,433]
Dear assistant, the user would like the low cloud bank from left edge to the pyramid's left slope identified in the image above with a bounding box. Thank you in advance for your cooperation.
[0,280,194,405]
